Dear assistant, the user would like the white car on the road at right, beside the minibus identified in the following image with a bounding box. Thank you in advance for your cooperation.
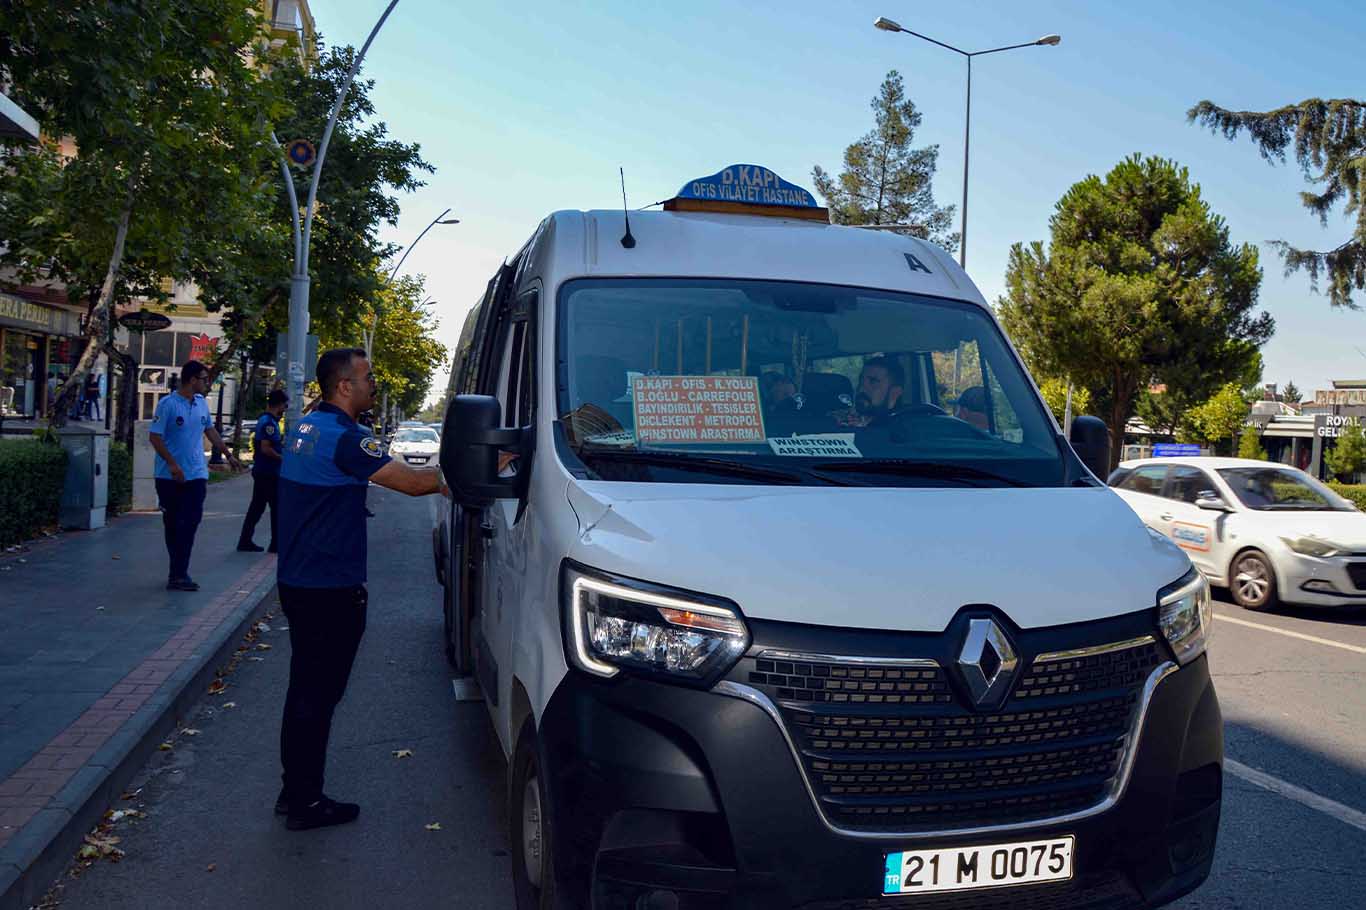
[1109,458,1366,609]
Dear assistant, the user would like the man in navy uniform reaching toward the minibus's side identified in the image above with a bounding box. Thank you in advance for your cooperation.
[275,347,443,831]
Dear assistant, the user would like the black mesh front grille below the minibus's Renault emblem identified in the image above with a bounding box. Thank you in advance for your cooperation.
[732,637,1167,832]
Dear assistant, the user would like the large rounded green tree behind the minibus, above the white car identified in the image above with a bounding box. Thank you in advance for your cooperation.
[997,154,1274,466]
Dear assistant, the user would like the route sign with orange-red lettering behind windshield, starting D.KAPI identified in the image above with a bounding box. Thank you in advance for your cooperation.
[631,376,765,445]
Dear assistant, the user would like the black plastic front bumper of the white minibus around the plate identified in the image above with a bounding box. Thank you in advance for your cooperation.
[538,647,1223,910]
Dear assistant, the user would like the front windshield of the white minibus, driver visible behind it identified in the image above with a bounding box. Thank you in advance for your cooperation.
[556,279,1067,486]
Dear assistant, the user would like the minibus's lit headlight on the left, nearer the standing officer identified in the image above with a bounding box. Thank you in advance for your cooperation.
[563,564,750,687]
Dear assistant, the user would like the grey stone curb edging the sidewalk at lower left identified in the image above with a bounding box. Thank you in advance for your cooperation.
[0,568,275,910]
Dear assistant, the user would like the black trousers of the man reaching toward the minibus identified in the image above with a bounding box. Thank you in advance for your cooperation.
[280,585,369,803]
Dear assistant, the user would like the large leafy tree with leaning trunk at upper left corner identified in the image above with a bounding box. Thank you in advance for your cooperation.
[0,0,284,422]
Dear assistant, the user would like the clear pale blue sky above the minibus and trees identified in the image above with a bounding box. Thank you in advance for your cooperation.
[313,0,1366,404]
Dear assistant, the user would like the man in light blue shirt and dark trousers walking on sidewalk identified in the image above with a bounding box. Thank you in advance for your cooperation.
[149,361,242,590]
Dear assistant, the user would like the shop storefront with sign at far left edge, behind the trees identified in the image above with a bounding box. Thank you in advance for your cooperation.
[0,292,81,417]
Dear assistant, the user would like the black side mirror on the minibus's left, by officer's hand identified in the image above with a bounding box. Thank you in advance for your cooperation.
[441,395,531,508]
